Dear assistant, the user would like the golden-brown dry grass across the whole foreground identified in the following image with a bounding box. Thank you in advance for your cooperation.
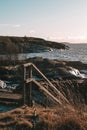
[0,105,87,130]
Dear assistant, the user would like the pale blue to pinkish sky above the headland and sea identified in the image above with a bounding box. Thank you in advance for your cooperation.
[0,0,87,43]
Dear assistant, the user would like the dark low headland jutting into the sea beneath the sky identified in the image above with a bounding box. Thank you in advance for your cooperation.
[0,36,69,54]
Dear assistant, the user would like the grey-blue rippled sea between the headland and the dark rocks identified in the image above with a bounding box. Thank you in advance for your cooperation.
[19,43,87,63]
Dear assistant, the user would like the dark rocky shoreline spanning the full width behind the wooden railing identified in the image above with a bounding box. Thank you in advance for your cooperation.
[0,57,87,79]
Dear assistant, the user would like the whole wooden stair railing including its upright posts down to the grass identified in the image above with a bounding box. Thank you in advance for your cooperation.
[23,63,69,106]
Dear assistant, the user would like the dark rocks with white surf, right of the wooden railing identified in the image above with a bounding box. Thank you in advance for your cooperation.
[27,57,87,79]
